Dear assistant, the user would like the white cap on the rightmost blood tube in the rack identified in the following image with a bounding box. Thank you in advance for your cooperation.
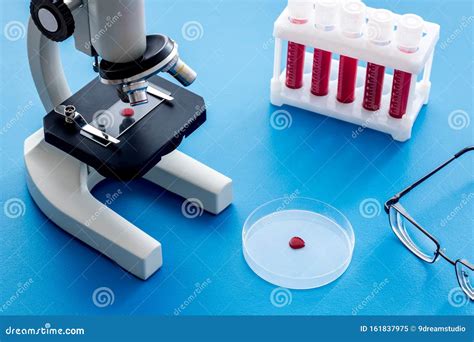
[396,14,424,52]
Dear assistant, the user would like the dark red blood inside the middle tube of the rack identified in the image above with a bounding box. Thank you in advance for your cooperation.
[337,56,357,103]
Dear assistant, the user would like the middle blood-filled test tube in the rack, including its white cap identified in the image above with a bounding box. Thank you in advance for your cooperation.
[337,0,366,103]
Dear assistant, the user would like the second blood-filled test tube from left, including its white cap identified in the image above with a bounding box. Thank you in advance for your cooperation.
[311,0,338,96]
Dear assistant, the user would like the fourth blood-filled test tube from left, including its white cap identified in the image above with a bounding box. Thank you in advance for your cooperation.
[362,9,394,111]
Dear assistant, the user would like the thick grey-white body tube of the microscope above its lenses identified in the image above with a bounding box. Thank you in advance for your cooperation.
[88,0,146,63]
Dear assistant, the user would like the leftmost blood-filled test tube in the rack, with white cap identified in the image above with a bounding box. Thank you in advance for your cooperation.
[285,0,313,89]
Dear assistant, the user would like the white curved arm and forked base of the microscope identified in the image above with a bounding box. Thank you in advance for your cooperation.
[24,20,232,279]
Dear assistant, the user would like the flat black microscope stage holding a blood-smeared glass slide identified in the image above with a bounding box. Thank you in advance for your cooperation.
[43,76,206,180]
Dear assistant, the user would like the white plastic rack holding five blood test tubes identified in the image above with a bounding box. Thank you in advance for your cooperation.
[271,7,440,141]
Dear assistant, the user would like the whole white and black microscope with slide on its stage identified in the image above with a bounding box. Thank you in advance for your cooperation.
[24,0,232,279]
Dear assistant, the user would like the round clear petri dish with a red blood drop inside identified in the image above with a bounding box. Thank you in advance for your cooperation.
[242,197,355,289]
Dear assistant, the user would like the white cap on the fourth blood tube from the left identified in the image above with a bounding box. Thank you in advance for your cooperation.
[367,9,394,45]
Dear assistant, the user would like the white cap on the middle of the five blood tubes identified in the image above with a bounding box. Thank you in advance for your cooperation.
[340,0,366,38]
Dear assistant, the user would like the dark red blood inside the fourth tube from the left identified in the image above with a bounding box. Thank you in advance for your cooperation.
[362,63,385,111]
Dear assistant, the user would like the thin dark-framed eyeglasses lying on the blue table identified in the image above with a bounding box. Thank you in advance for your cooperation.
[384,146,474,300]
